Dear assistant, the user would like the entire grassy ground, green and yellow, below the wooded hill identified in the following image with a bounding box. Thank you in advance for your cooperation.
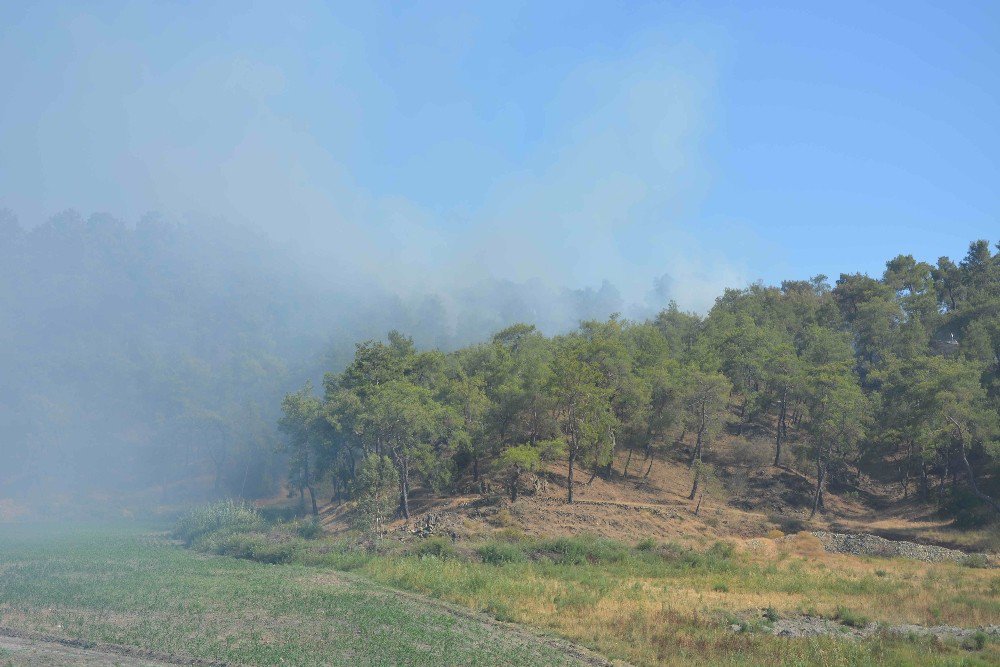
[0,524,1000,665]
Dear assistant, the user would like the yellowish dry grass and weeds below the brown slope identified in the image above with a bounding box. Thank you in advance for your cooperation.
[174,508,1000,665]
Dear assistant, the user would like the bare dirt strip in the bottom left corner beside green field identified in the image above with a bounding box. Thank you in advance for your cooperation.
[0,628,225,667]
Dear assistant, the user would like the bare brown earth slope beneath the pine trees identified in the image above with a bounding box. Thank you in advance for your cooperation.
[308,435,1000,552]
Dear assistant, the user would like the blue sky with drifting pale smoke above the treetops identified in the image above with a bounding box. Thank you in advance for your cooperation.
[0,1,1000,309]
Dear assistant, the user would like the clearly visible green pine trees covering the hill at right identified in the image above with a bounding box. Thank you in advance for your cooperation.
[280,241,1000,527]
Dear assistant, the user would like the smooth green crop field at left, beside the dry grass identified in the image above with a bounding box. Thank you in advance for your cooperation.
[0,525,592,665]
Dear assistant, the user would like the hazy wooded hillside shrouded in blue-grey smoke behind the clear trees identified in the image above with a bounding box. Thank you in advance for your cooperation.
[0,211,648,504]
